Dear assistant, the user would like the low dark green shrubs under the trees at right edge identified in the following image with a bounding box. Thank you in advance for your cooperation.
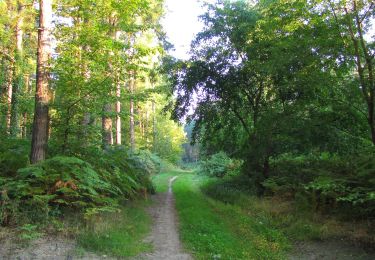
[263,150,375,217]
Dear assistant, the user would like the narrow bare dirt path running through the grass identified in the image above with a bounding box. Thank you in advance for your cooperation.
[140,176,193,260]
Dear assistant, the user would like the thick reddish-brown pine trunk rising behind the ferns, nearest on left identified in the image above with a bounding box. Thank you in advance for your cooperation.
[30,0,52,164]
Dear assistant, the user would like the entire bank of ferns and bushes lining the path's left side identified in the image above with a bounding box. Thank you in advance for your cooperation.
[0,142,160,224]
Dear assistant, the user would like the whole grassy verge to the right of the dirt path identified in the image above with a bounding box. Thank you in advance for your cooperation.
[153,171,374,259]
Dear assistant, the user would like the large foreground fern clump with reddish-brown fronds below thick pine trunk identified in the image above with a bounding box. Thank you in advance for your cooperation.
[3,156,116,222]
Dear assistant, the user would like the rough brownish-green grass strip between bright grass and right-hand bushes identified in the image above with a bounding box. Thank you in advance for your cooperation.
[201,176,375,245]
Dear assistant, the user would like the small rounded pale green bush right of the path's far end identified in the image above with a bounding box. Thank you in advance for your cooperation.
[199,152,241,178]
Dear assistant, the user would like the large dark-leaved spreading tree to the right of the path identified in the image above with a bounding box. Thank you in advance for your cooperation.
[170,1,369,188]
